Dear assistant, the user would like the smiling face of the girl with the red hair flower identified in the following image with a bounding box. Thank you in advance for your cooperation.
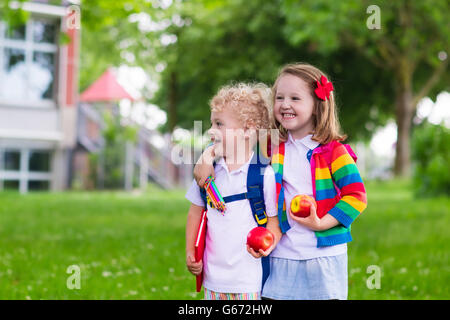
[273,74,314,139]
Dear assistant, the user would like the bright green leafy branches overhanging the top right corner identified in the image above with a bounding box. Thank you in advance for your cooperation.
[282,0,450,69]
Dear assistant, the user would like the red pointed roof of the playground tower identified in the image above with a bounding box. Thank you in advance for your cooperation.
[80,69,135,102]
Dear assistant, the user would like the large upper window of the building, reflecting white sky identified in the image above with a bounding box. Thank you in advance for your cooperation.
[0,18,58,104]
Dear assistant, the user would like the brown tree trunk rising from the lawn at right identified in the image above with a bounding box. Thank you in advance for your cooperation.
[394,83,414,177]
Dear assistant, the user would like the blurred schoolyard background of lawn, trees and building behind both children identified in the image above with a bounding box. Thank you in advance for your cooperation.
[0,0,450,299]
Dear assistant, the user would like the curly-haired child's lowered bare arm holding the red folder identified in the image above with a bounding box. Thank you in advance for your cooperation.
[186,204,203,275]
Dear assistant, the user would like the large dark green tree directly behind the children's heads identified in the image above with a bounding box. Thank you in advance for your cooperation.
[154,0,394,140]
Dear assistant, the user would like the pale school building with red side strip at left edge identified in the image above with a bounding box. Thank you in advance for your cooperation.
[0,1,79,193]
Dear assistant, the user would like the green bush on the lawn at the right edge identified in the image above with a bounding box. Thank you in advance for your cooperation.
[412,121,450,196]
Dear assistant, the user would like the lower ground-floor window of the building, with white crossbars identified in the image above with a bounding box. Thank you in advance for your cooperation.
[0,149,52,193]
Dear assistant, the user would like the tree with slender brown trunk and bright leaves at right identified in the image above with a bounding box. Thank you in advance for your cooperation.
[282,0,450,176]
